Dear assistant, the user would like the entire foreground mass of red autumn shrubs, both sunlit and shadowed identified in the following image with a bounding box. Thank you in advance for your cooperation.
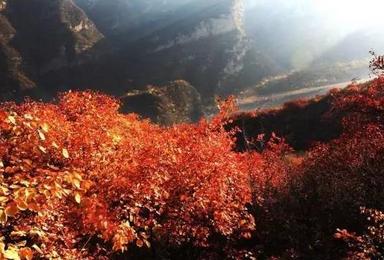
[0,77,384,259]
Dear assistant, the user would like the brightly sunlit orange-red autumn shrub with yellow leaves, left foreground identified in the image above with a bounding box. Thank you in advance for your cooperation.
[0,92,292,259]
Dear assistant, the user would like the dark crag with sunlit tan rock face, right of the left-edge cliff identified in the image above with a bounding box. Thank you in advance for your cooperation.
[6,0,103,75]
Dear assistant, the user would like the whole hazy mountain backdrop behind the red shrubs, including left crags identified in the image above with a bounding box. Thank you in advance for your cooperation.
[0,0,384,114]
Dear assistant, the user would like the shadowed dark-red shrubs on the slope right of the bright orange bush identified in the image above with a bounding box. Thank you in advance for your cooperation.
[225,77,384,259]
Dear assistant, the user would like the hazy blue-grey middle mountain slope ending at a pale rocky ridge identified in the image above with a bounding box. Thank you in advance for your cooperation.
[70,0,275,102]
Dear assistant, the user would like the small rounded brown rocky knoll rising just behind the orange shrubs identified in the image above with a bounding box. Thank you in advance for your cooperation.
[122,80,203,125]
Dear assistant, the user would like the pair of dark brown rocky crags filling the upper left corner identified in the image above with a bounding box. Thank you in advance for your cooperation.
[0,0,103,99]
